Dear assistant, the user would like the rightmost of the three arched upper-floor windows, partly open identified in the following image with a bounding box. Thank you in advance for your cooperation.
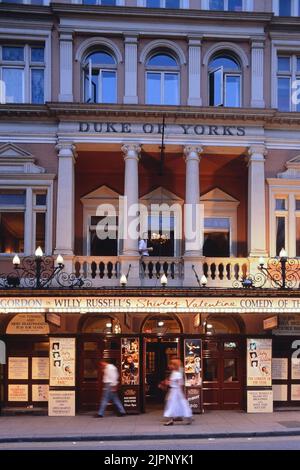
[208,52,242,108]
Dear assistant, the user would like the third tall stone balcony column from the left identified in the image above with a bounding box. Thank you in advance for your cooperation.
[184,145,203,256]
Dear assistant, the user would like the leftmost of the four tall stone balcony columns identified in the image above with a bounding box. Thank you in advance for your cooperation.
[55,142,77,256]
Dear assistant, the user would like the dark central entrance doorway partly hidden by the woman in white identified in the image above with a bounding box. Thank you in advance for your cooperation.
[144,338,179,406]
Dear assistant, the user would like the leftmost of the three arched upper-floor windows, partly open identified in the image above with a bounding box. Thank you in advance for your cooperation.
[83,51,117,103]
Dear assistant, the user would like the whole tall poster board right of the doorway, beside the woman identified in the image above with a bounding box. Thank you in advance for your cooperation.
[184,338,202,413]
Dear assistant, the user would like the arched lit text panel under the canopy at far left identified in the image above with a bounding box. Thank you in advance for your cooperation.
[6,312,49,335]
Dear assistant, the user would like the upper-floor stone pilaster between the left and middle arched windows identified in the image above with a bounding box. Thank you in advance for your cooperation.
[124,36,138,104]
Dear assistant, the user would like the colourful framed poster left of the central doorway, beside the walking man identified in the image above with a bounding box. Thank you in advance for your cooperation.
[121,338,140,385]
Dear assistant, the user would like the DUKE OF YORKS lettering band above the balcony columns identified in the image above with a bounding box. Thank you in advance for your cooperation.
[79,122,246,137]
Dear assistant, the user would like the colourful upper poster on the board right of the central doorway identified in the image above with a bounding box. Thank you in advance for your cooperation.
[184,339,202,387]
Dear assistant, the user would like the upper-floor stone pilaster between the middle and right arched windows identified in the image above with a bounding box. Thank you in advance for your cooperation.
[188,38,202,106]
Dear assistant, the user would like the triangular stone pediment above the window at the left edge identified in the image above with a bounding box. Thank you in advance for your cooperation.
[0,143,46,174]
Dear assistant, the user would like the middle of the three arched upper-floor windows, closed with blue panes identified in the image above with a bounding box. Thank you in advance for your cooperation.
[146,52,180,105]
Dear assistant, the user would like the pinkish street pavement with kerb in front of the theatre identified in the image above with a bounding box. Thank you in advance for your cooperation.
[0,410,300,443]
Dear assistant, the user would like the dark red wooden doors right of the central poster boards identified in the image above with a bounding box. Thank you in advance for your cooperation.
[203,337,245,410]
